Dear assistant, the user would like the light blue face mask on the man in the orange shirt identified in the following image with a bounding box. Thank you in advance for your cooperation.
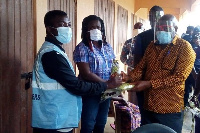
[156,31,172,44]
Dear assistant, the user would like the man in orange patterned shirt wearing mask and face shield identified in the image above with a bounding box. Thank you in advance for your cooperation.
[125,14,195,133]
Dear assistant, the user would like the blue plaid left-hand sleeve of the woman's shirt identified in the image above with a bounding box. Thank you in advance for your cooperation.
[73,43,89,63]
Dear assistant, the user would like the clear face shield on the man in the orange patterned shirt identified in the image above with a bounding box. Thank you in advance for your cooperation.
[154,21,176,45]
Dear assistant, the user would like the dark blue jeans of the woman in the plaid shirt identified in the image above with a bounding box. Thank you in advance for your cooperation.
[80,95,110,133]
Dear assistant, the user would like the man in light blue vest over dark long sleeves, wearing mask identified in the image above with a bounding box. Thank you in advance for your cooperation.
[32,10,121,133]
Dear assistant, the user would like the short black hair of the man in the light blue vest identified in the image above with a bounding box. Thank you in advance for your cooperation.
[44,10,67,27]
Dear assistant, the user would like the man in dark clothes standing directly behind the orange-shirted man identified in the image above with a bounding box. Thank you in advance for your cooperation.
[134,6,164,125]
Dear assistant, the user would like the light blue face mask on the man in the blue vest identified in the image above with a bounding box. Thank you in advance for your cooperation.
[55,27,72,44]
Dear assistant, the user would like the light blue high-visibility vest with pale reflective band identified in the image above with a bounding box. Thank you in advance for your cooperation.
[32,42,82,129]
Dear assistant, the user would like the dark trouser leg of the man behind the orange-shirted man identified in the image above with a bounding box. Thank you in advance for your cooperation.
[136,91,144,126]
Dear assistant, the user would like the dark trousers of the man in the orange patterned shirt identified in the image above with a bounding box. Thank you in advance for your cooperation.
[144,110,183,133]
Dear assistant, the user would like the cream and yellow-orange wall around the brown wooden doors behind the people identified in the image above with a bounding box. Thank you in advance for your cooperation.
[35,0,200,50]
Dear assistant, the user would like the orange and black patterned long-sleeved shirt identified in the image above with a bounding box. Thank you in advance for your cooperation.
[129,36,196,113]
